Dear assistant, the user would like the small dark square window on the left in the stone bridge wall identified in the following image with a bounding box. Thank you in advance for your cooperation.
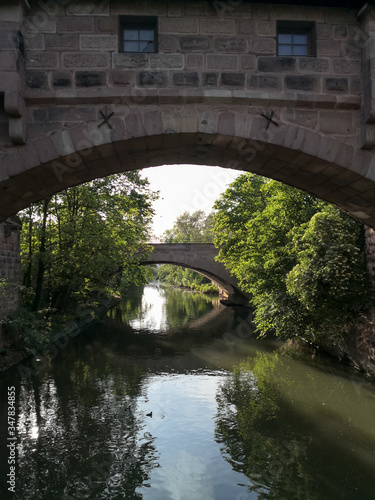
[119,16,158,52]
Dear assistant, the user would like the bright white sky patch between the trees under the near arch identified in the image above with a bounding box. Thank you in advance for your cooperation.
[141,165,242,237]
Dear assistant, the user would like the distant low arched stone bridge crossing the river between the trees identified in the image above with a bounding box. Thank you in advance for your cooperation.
[138,243,250,305]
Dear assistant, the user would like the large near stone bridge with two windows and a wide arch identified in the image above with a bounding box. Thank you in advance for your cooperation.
[0,0,375,320]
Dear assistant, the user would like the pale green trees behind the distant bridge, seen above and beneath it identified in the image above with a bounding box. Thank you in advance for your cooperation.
[157,210,218,294]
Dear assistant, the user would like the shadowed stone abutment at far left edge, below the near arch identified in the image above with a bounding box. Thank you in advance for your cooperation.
[0,223,21,347]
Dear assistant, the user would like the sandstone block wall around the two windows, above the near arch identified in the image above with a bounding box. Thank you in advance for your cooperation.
[25,0,363,145]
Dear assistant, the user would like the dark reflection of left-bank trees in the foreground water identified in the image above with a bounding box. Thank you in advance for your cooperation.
[12,345,158,500]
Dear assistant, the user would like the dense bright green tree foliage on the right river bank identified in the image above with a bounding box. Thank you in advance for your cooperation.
[214,174,369,341]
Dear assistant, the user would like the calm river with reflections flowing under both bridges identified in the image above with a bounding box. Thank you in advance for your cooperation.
[0,284,375,500]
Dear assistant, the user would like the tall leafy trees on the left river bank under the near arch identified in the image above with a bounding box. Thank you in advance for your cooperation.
[2,172,157,349]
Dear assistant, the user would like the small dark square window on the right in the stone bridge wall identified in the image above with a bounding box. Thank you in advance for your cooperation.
[277,21,316,56]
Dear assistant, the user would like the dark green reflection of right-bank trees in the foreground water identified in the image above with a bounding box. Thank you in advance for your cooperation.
[216,352,375,500]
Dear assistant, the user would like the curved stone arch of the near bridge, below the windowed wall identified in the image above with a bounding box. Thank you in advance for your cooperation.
[0,102,375,226]
